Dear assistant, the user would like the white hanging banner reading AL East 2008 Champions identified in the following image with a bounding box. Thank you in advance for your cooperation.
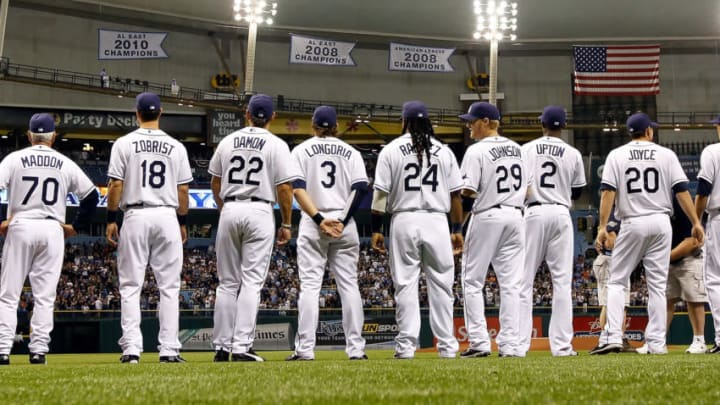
[290,35,357,66]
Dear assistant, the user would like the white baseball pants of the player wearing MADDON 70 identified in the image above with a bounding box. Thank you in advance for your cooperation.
[0,218,65,354]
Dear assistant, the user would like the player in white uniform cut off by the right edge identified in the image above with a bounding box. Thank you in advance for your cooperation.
[695,115,720,354]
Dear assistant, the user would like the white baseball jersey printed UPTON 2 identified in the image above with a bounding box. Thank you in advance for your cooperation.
[522,136,587,207]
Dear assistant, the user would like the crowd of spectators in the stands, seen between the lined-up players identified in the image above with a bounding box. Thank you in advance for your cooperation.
[0,243,647,311]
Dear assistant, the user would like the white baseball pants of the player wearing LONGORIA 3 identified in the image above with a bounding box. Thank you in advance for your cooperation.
[295,212,365,359]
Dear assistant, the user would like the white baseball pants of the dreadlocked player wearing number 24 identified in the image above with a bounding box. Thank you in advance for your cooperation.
[389,212,458,358]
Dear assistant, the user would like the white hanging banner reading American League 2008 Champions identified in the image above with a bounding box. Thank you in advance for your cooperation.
[388,42,455,72]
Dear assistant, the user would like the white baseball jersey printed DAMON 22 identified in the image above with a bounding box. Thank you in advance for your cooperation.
[208,127,299,202]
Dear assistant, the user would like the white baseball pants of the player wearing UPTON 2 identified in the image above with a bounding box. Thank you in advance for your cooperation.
[520,204,574,356]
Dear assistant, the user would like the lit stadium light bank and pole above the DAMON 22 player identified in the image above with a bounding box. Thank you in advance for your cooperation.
[233,0,277,95]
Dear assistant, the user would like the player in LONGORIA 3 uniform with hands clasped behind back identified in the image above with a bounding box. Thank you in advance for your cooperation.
[287,106,368,361]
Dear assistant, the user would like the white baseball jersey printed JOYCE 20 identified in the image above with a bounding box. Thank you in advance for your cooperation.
[602,141,688,221]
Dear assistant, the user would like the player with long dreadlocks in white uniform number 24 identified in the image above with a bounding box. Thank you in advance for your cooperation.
[372,101,463,359]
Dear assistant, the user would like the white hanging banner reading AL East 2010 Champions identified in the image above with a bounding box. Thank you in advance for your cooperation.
[98,29,168,59]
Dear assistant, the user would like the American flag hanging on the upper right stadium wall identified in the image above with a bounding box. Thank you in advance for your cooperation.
[573,45,660,96]
